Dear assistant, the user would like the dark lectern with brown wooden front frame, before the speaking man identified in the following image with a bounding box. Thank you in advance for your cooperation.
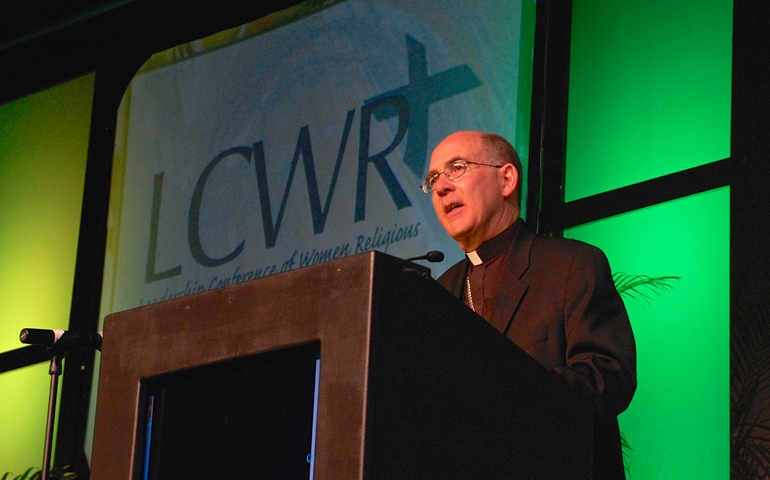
[91,252,592,480]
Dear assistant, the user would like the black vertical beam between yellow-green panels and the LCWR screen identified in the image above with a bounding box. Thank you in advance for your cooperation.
[54,56,146,478]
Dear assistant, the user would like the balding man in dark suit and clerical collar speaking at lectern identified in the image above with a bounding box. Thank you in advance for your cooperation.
[422,132,636,479]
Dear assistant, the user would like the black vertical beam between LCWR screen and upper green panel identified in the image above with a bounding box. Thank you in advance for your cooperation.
[527,0,572,235]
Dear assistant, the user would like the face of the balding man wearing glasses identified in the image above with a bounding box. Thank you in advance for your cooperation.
[428,132,518,252]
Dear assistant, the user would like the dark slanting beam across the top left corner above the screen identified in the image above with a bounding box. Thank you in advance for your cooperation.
[0,0,301,104]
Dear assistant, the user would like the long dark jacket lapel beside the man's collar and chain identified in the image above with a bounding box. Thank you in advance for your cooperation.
[486,225,535,335]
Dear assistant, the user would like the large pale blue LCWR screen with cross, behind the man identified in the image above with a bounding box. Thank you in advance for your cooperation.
[97,0,535,315]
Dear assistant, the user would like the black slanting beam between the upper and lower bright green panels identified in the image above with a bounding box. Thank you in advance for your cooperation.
[543,158,731,231]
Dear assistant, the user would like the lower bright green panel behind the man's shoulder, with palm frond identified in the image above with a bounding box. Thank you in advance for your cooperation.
[564,187,730,480]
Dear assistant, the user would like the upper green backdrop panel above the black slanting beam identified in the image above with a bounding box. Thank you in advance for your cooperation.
[565,0,733,201]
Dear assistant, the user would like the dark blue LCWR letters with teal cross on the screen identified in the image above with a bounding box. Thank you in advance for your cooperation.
[145,35,481,283]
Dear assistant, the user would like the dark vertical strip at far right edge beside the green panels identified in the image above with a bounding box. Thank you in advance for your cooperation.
[730,0,770,479]
